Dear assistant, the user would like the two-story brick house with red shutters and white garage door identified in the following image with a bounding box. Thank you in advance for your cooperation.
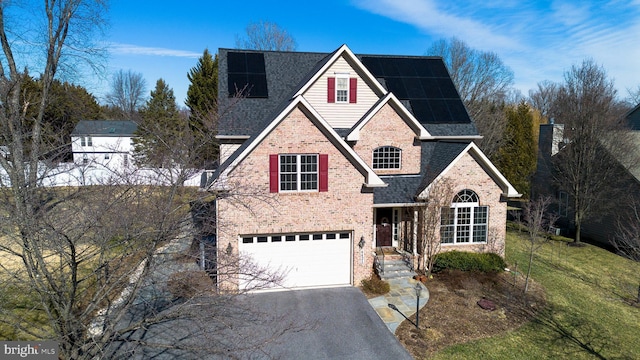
[209,45,520,288]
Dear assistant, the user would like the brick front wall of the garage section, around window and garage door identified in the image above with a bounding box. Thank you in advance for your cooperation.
[218,105,373,288]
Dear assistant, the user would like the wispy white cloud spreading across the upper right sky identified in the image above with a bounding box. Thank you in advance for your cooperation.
[355,0,640,94]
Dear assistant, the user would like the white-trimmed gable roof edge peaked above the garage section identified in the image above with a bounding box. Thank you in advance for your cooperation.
[212,96,387,190]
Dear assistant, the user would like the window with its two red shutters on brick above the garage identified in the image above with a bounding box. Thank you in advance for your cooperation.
[269,154,328,192]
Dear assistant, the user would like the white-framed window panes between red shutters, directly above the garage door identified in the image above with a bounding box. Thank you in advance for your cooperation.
[280,154,318,191]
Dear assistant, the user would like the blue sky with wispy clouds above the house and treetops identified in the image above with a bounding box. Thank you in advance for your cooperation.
[94,0,640,105]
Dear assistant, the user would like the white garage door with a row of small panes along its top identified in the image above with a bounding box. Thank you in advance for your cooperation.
[239,232,352,289]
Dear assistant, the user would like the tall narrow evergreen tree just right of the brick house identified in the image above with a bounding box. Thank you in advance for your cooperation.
[496,102,536,198]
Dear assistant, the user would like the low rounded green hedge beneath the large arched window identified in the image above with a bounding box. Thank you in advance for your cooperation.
[432,250,507,273]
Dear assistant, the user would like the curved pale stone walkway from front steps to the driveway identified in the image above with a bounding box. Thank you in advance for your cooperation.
[369,277,429,334]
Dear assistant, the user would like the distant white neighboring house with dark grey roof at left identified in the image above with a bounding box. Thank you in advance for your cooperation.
[71,120,138,170]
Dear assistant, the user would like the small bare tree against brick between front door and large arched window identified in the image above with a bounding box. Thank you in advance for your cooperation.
[418,178,454,273]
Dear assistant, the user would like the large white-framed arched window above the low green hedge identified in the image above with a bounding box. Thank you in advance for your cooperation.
[440,189,489,244]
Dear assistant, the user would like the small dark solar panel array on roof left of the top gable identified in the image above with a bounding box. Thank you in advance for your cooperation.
[227,52,269,98]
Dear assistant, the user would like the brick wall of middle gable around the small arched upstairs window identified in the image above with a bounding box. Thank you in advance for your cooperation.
[353,104,420,175]
